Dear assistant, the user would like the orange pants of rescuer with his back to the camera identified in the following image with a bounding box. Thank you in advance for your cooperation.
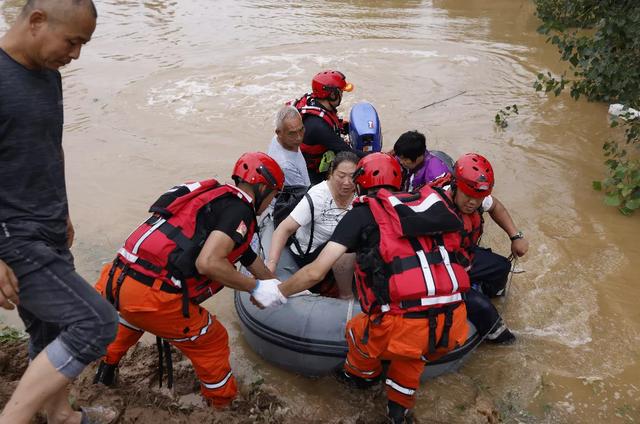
[344,304,468,408]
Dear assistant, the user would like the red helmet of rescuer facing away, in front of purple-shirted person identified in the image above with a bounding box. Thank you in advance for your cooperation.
[354,152,402,190]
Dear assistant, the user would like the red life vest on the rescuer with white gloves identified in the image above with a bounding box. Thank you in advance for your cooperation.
[116,179,256,303]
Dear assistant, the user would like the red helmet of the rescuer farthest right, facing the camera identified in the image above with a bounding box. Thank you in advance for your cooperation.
[453,153,495,197]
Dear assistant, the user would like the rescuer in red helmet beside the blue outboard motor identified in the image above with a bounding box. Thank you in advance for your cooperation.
[291,70,365,185]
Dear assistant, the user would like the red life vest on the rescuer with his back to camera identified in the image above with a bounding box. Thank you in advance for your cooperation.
[354,186,469,314]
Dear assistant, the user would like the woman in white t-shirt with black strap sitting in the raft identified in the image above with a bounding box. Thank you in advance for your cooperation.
[267,152,359,299]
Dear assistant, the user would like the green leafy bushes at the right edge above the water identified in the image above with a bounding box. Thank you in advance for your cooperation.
[534,0,640,215]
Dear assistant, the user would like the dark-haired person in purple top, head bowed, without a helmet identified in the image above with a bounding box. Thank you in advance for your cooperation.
[393,131,450,191]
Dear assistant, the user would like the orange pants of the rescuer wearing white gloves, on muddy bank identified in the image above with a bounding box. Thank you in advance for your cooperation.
[96,264,238,407]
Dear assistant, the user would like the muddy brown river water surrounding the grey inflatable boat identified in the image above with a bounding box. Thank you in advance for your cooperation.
[0,0,640,423]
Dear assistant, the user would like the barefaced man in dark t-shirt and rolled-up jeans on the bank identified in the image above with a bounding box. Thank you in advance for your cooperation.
[0,0,117,424]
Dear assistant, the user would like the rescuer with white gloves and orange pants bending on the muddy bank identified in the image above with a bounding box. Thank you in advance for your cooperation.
[94,152,286,408]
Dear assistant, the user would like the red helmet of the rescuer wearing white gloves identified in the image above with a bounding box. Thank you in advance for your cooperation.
[231,152,284,190]
